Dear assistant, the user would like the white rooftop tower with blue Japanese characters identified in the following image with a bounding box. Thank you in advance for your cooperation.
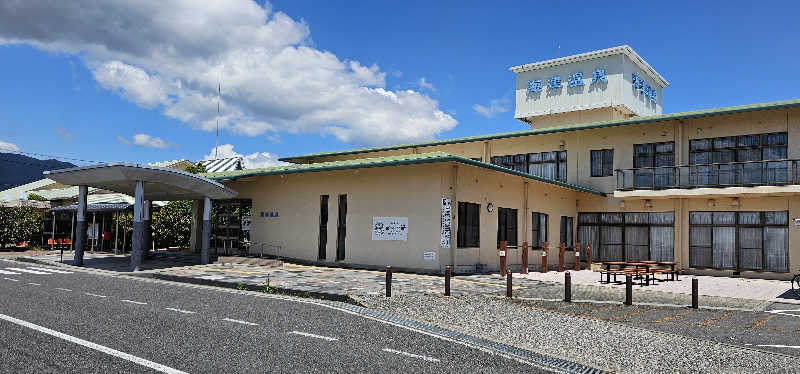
[510,45,669,128]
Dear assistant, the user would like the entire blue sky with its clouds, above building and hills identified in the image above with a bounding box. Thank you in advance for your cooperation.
[0,0,800,166]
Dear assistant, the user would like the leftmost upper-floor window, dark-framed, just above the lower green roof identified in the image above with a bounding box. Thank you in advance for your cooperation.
[491,151,567,182]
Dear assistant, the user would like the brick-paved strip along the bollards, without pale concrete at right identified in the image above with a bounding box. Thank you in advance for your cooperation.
[17,251,776,310]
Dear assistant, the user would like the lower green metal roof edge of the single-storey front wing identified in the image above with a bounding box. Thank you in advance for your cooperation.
[199,152,605,196]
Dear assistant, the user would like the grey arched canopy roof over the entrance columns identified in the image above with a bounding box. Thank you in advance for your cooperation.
[44,163,237,201]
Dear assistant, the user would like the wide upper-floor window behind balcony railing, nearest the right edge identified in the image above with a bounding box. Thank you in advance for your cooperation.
[689,132,791,185]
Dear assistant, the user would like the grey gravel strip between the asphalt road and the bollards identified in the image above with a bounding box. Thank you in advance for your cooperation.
[359,296,800,374]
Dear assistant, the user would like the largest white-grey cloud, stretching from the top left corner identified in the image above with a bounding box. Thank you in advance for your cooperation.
[0,0,457,144]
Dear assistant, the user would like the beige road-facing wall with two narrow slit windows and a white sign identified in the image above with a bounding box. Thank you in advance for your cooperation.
[227,164,446,271]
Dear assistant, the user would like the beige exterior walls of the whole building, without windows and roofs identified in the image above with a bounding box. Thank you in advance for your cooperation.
[247,108,800,278]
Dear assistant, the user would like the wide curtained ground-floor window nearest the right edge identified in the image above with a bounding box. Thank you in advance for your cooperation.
[689,211,789,271]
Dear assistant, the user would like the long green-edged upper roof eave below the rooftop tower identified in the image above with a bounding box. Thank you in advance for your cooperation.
[279,99,800,162]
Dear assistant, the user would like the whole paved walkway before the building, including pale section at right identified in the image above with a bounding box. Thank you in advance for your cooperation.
[14,252,800,310]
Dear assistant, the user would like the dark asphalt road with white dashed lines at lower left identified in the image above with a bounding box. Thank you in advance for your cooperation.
[0,261,556,373]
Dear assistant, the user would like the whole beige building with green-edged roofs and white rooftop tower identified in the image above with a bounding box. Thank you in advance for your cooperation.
[207,46,800,278]
